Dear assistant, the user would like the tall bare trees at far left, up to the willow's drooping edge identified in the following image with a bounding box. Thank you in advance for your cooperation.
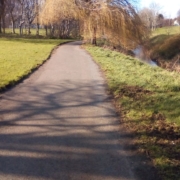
[0,0,42,34]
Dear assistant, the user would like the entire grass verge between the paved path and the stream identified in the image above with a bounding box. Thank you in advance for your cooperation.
[85,46,180,180]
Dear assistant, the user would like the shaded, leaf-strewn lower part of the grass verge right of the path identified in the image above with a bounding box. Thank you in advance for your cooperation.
[116,84,180,179]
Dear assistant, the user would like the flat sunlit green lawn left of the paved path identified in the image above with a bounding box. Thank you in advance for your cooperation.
[0,38,71,90]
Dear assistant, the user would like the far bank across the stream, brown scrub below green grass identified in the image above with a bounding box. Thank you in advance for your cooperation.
[145,26,180,72]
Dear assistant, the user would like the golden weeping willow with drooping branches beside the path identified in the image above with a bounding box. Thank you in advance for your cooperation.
[41,0,147,48]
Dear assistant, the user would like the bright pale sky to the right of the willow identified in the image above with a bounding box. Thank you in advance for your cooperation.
[140,0,180,18]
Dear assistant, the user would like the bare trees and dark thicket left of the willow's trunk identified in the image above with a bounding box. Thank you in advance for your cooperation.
[0,0,79,38]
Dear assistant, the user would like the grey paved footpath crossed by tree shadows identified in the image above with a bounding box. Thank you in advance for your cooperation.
[0,42,158,180]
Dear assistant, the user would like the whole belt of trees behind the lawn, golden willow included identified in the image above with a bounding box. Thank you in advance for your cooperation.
[0,0,147,48]
